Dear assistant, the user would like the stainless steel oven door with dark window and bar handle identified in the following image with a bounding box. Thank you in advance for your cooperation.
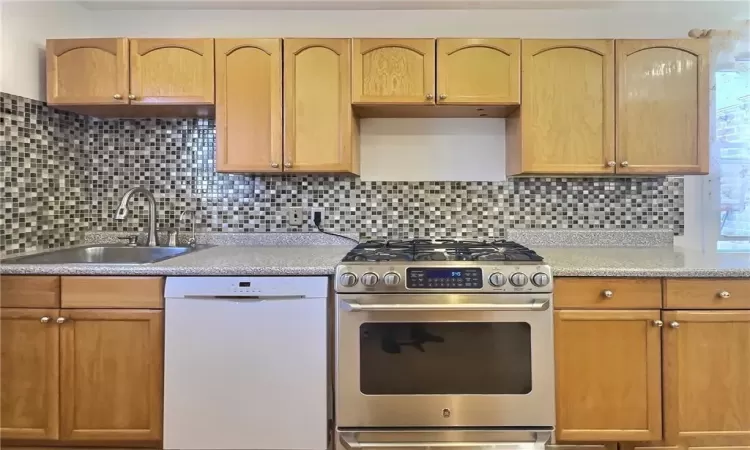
[335,294,554,428]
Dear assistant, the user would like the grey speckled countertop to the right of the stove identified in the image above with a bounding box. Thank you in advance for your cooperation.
[534,247,750,278]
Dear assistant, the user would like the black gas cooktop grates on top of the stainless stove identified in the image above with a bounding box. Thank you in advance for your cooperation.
[344,239,542,262]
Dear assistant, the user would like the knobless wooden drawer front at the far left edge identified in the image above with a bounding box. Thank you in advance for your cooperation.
[0,275,60,308]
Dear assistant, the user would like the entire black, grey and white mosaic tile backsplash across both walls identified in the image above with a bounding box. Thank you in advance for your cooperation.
[0,90,684,254]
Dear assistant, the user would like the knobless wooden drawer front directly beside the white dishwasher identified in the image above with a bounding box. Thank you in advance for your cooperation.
[61,277,164,309]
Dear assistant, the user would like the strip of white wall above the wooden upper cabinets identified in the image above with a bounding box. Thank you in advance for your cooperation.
[83,6,746,38]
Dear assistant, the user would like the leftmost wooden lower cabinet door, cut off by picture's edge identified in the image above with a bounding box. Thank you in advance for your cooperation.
[0,308,60,439]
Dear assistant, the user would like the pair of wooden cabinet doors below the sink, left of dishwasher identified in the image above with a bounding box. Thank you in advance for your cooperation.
[0,308,164,447]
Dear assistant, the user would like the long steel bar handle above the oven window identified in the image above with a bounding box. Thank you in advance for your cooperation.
[341,299,549,312]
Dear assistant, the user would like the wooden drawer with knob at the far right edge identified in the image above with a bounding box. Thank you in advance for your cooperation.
[664,278,750,309]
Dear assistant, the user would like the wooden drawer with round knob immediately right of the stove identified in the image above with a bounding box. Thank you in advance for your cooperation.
[554,277,661,309]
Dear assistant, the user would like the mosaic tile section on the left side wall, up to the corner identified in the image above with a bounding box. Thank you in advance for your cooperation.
[0,94,89,254]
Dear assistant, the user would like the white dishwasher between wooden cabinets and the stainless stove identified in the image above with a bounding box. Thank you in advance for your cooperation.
[164,277,329,450]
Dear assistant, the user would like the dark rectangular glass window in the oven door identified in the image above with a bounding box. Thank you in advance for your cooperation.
[359,322,531,395]
